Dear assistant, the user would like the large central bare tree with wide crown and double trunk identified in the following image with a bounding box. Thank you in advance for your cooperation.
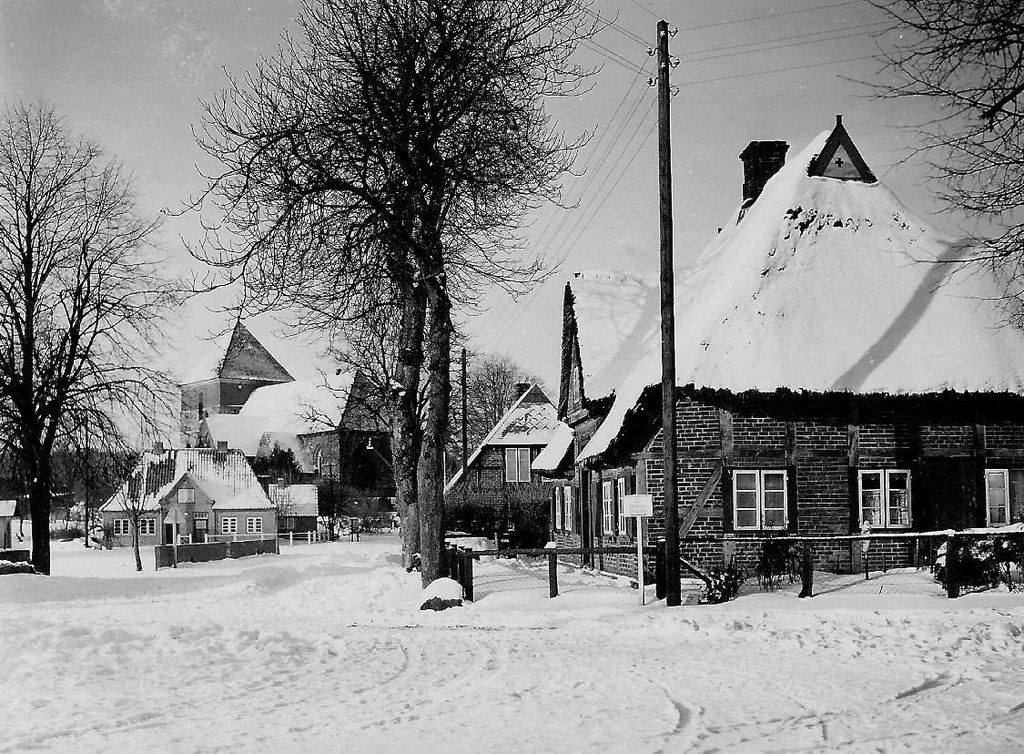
[192,0,594,583]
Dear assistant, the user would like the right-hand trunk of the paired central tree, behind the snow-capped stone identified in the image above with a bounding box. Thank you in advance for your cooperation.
[419,278,453,586]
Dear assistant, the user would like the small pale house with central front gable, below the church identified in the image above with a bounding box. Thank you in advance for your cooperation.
[99,446,278,545]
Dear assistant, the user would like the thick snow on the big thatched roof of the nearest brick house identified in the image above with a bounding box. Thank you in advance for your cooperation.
[580,122,1024,460]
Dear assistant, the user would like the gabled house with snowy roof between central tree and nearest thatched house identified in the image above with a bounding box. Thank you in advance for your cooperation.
[444,384,559,546]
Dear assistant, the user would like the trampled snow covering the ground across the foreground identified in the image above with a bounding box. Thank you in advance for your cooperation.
[0,537,1024,754]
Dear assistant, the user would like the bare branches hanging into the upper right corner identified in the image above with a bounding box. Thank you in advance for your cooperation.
[873,0,1024,295]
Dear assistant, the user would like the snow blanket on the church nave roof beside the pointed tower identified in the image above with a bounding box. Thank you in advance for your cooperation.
[239,375,352,434]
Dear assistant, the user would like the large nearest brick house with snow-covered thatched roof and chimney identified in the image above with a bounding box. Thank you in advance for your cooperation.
[561,118,1024,573]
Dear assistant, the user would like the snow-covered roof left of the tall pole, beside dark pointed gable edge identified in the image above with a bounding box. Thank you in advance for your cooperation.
[569,270,659,399]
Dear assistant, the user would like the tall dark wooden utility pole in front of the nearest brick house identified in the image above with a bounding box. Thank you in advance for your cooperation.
[657,20,682,608]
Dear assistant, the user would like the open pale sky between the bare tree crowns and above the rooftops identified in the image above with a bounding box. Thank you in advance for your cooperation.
[0,0,942,387]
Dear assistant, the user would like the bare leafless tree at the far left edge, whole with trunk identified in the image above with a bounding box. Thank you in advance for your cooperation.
[0,104,172,574]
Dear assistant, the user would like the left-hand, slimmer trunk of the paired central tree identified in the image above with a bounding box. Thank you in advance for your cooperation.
[391,284,426,571]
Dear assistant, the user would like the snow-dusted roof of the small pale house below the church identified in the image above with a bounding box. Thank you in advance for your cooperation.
[99,448,272,511]
